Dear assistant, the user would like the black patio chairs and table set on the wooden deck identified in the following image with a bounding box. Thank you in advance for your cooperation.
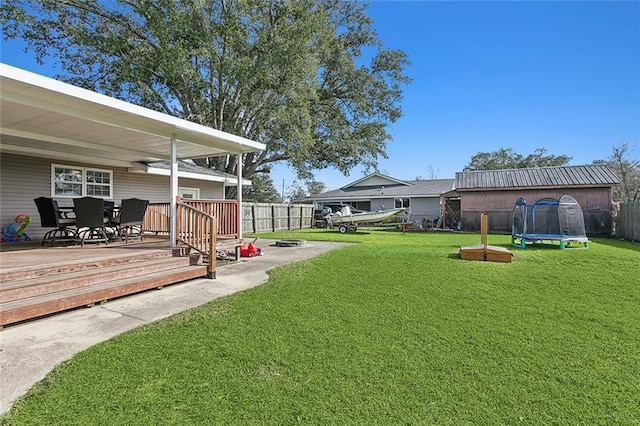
[33,197,149,247]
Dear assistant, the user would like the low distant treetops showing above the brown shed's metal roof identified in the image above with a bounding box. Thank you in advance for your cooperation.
[464,148,571,171]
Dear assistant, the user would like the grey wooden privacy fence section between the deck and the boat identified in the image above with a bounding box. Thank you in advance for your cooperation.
[242,203,314,233]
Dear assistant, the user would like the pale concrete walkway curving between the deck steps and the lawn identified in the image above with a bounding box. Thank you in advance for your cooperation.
[0,239,345,414]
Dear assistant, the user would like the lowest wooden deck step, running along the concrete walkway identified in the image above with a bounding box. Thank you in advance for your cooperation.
[0,265,207,326]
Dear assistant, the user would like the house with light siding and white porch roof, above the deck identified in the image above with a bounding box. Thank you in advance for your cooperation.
[0,64,265,238]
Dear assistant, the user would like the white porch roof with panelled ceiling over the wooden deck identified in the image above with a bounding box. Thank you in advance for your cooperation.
[0,64,266,167]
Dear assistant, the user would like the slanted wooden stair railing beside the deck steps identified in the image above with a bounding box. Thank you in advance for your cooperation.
[176,200,217,278]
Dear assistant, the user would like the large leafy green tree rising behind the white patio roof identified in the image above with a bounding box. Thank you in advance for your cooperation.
[0,0,410,194]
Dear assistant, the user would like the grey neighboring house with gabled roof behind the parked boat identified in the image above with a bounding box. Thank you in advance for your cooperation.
[309,173,454,224]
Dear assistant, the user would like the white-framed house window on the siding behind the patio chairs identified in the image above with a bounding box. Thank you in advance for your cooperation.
[51,164,113,198]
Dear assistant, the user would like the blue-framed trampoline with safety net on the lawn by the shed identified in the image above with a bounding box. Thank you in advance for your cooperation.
[511,195,589,250]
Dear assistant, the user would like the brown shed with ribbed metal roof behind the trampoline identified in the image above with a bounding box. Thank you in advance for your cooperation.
[447,164,620,235]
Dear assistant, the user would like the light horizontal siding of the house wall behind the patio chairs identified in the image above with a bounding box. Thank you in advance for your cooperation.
[0,154,224,239]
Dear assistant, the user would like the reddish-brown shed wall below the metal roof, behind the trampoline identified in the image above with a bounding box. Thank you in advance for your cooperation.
[460,188,611,235]
